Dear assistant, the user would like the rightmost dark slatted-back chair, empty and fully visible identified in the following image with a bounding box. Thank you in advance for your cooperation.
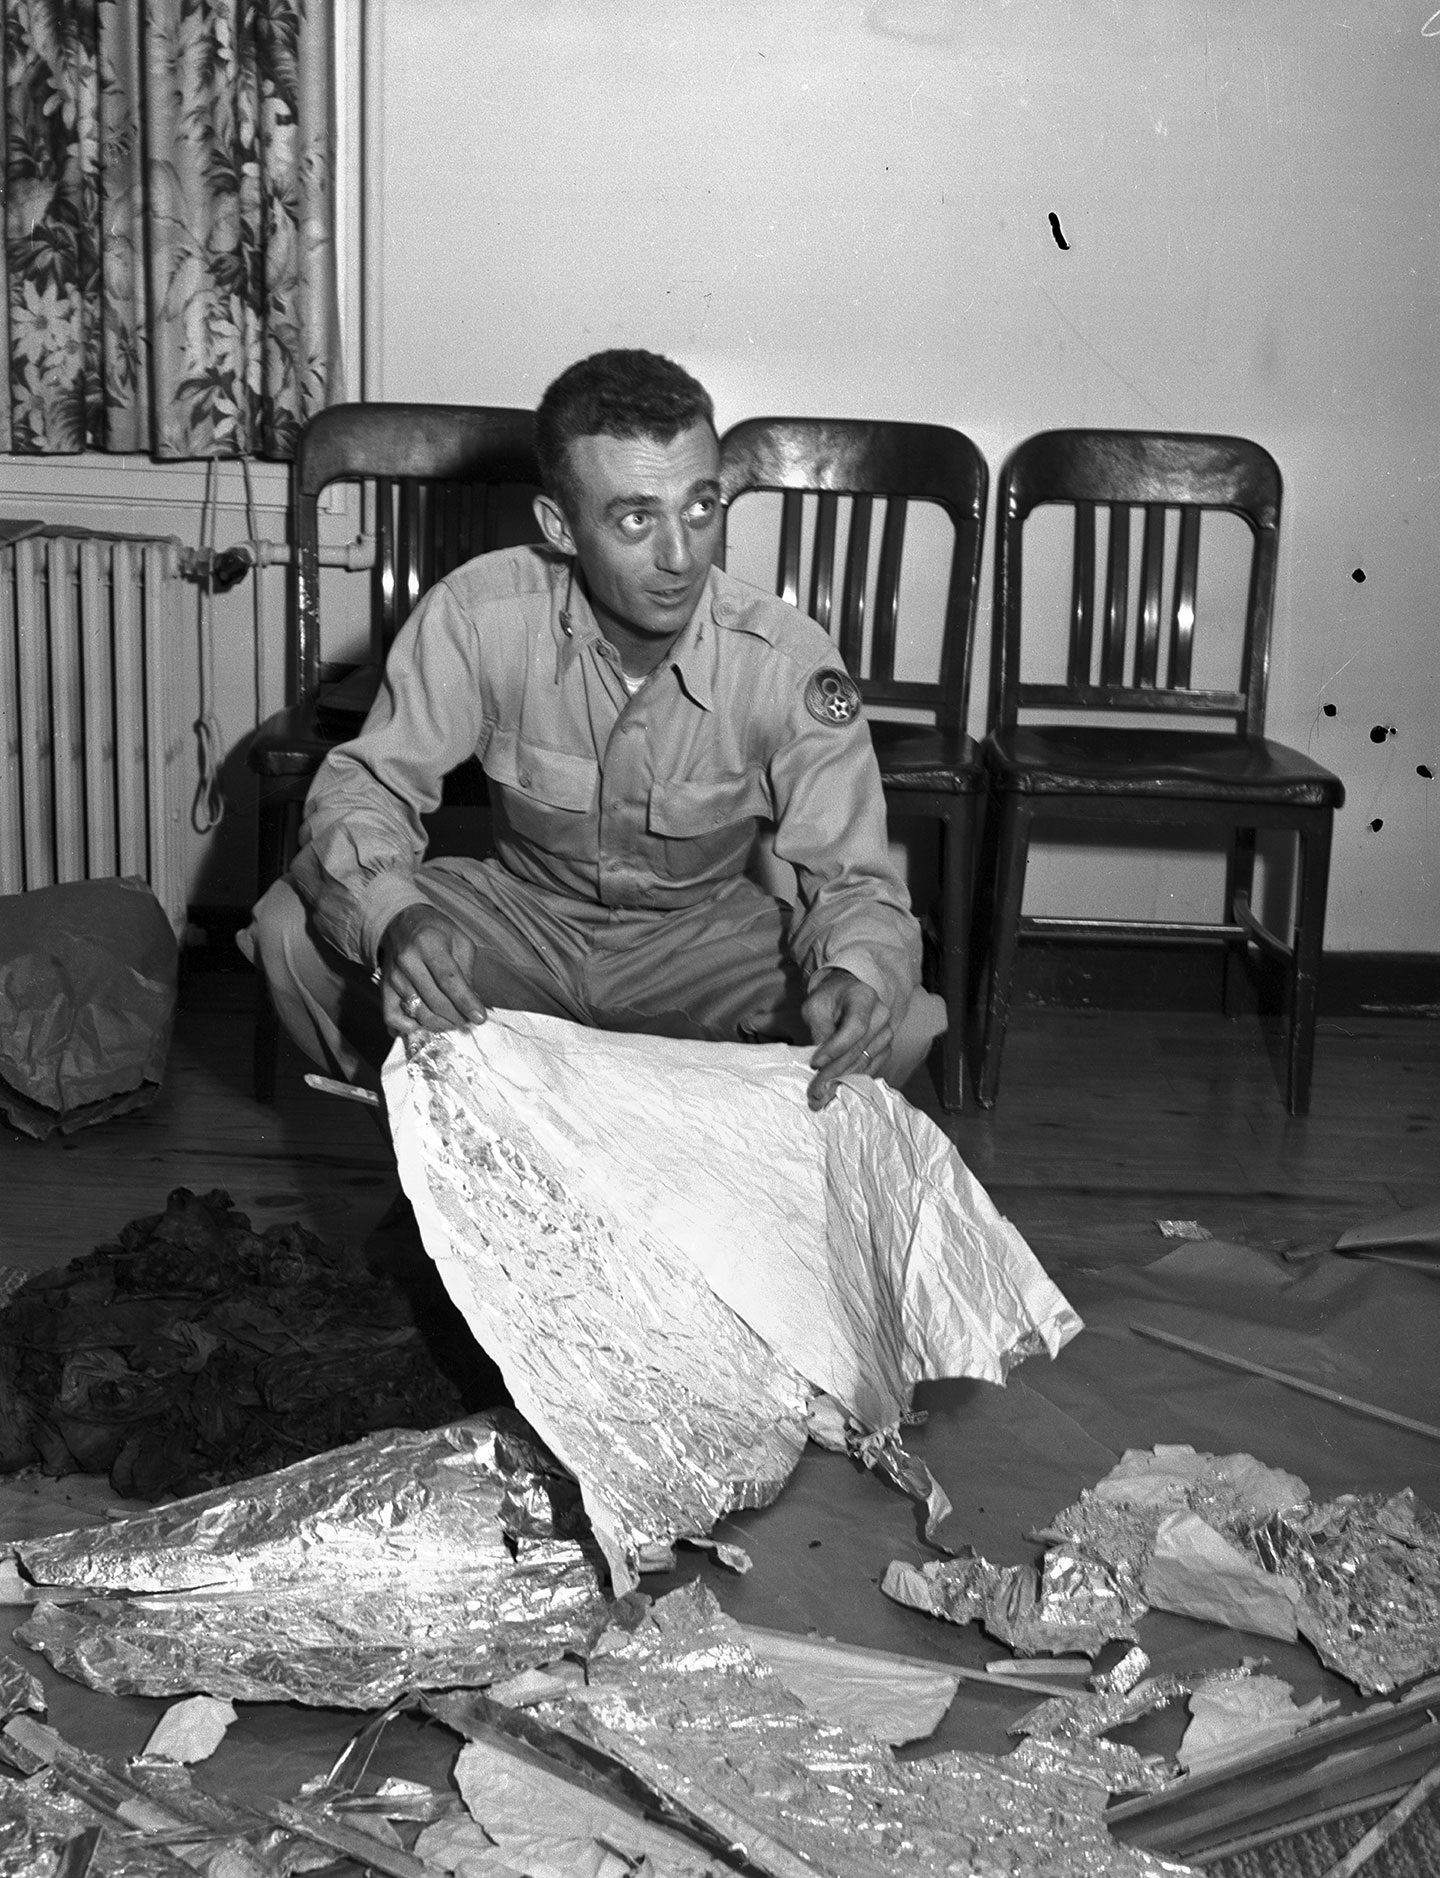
[978,430,1344,1116]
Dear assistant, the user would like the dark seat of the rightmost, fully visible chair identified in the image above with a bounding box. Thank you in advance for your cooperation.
[984,725,1344,809]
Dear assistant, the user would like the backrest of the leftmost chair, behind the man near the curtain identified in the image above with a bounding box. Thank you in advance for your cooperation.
[289,404,539,702]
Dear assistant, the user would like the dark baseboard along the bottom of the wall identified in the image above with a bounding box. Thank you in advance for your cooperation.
[186,907,1440,1018]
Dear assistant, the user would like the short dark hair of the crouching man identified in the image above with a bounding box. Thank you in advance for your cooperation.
[535,349,715,511]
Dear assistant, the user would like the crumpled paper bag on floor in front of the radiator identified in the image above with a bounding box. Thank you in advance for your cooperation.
[0,879,180,1140]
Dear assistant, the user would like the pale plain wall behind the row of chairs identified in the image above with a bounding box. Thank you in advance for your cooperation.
[372,0,1440,950]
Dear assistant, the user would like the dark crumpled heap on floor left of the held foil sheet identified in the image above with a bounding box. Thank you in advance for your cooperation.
[0,1187,466,1499]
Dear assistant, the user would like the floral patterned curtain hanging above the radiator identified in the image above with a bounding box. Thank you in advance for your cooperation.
[0,0,342,460]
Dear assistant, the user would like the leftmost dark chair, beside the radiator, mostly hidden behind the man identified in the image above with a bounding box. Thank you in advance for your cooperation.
[248,404,539,1101]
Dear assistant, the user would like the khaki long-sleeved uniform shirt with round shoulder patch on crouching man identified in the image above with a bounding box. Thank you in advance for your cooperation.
[291,546,920,1016]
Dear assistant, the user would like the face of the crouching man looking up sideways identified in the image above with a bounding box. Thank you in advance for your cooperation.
[541,423,721,639]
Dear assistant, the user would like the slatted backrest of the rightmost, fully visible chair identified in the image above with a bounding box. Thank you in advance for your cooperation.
[991,430,1282,734]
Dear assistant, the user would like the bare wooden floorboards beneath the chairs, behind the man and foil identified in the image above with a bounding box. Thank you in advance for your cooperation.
[0,975,1440,1279]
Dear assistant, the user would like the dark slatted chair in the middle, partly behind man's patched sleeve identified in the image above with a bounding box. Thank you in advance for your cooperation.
[721,417,989,1110]
